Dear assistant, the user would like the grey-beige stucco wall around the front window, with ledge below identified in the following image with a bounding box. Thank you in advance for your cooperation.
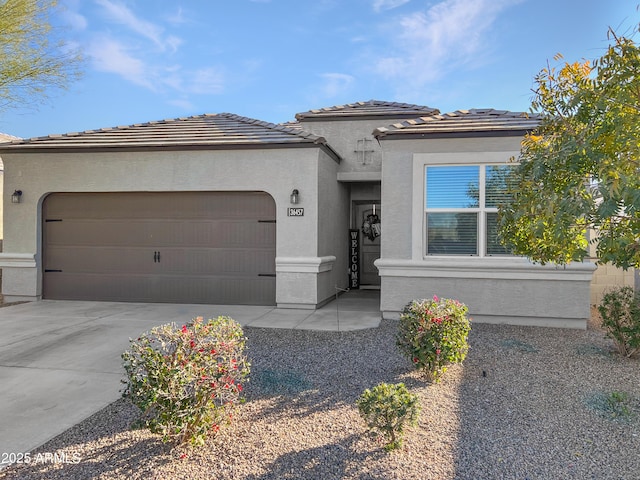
[377,137,593,328]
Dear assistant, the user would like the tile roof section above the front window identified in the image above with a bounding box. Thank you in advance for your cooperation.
[373,108,540,140]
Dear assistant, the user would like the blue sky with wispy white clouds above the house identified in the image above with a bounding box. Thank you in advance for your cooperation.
[0,0,640,138]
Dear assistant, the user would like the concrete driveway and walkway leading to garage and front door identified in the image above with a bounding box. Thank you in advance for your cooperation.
[0,290,380,468]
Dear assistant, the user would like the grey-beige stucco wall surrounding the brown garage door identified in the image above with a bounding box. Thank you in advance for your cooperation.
[0,147,348,308]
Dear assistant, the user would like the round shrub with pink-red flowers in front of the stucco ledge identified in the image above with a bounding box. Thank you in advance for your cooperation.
[396,295,471,382]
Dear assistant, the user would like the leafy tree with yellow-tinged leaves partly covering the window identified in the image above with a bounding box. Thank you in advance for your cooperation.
[500,24,640,269]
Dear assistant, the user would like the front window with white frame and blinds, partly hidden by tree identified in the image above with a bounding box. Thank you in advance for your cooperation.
[425,165,510,256]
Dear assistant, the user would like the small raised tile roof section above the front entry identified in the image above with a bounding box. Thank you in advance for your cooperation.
[296,100,440,121]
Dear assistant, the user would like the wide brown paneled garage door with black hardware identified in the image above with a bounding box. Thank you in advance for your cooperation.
[43,192,276,305]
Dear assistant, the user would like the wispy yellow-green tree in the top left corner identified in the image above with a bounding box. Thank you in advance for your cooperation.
[0,0,81,109]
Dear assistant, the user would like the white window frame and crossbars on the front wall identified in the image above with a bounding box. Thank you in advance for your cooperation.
[422,162,513,258]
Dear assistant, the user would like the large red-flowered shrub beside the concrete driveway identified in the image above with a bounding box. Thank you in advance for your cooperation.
[122,317,249,445]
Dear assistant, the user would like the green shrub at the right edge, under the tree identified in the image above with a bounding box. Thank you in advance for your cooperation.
[598,286,640,357]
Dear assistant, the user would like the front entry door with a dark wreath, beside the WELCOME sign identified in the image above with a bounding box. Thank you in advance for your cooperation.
[354,200,382,287]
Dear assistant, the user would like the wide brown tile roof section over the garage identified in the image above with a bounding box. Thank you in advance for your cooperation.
[0,113,336,151]
